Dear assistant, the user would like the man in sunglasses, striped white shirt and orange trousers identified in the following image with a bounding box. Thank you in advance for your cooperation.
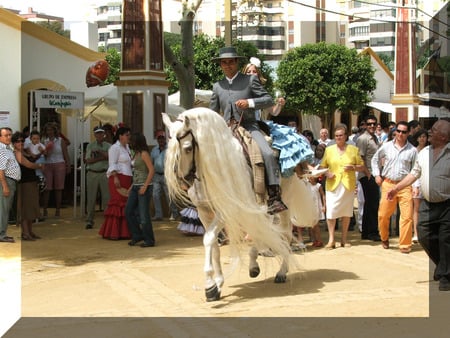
[372,121,417,254]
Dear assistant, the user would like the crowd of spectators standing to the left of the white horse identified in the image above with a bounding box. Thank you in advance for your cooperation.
[0,122,186,248]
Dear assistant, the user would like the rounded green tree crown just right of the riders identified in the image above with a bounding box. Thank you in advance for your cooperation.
[277,42,376,128]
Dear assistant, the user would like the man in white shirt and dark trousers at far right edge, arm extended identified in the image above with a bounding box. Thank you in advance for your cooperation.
[387,120,450,291]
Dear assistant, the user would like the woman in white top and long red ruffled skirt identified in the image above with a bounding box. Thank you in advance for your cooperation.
[99,127,133,240]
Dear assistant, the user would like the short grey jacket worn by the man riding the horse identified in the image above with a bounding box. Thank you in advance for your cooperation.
[209,73,274,123]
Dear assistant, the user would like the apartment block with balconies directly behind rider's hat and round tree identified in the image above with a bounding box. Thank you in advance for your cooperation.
[231,0,341,60]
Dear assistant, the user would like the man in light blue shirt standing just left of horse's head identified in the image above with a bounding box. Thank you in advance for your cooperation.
[150,130,180,221]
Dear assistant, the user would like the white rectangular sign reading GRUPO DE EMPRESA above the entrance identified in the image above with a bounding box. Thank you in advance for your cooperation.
[34,90,84,109]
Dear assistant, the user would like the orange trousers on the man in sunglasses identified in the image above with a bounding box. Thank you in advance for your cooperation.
[378,181,413,248]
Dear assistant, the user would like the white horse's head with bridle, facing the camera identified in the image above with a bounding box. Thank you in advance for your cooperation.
[163,114,197,186]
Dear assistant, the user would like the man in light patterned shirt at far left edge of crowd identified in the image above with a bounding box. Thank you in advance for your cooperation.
[0,127,20,243]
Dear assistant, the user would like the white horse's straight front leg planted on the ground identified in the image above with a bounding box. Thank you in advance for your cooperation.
[202,213,224,302]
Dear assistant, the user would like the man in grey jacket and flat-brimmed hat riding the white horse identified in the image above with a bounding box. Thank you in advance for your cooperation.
[209,47,287,214]
